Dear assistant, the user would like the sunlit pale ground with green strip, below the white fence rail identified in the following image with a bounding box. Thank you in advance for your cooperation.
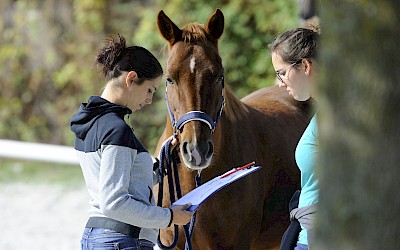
[0,159,89,250]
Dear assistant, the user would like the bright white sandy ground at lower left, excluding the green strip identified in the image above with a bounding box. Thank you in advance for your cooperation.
[0,184,89,250]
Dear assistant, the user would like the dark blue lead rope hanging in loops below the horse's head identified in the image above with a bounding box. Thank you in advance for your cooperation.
[157,140,201,250]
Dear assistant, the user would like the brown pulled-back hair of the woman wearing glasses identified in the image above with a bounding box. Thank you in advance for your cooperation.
[268,28,319,63]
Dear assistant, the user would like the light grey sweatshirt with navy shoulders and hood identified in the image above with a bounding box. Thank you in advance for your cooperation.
[71,96,171,243]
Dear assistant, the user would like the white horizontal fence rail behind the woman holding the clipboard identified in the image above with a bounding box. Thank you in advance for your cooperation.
[0,139,79,165]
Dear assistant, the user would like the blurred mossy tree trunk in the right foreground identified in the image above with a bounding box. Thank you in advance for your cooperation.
[314,0,400,250]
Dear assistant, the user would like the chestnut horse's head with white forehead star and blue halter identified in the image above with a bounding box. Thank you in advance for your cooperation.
[157,9,224,170]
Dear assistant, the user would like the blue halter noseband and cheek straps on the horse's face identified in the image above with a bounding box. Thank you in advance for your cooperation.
[165,83,225,137]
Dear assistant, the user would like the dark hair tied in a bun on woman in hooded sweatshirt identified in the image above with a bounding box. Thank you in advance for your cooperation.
[96,35,163,84]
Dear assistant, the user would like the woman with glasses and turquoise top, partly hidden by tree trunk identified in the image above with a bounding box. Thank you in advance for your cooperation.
[268,28,319,250]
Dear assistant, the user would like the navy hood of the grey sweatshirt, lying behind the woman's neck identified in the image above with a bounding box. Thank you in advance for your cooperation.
[70,96,132,139]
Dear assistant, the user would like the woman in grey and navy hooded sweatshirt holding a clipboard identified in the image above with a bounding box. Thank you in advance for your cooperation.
[71,36,193,249]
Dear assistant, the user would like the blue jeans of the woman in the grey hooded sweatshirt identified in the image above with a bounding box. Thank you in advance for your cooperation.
[81,228,154,250]
